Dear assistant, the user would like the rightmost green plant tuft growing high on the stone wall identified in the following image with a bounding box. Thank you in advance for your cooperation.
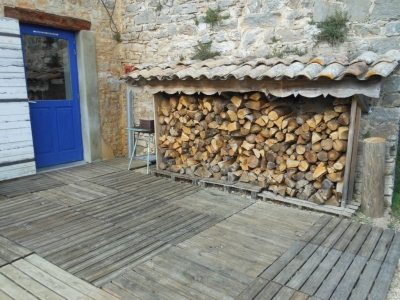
[314,11,349,46]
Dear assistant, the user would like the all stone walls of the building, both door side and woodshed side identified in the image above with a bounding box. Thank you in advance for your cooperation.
[0,0,400,204]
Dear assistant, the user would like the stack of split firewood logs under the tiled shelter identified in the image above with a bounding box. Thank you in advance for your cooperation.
[157,93,350,205]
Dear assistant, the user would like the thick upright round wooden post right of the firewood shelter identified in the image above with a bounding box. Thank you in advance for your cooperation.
[361,137,386,218]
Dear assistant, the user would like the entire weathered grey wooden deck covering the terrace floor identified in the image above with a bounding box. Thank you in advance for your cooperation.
[0,159,400,300]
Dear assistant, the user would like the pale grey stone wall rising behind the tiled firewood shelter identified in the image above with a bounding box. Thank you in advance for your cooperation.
[121,0,400,205]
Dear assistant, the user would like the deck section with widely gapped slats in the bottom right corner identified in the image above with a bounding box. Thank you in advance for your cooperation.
[238,216,400,300]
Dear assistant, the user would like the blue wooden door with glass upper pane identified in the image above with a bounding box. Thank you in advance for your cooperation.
[21,24,83,168]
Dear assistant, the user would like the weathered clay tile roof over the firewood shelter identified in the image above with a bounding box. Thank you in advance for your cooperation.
[126,50,400,81]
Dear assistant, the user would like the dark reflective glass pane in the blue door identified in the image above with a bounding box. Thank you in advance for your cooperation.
[22,34,72,100]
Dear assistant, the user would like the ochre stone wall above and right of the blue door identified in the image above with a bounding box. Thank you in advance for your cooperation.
[0,0,126,159]
